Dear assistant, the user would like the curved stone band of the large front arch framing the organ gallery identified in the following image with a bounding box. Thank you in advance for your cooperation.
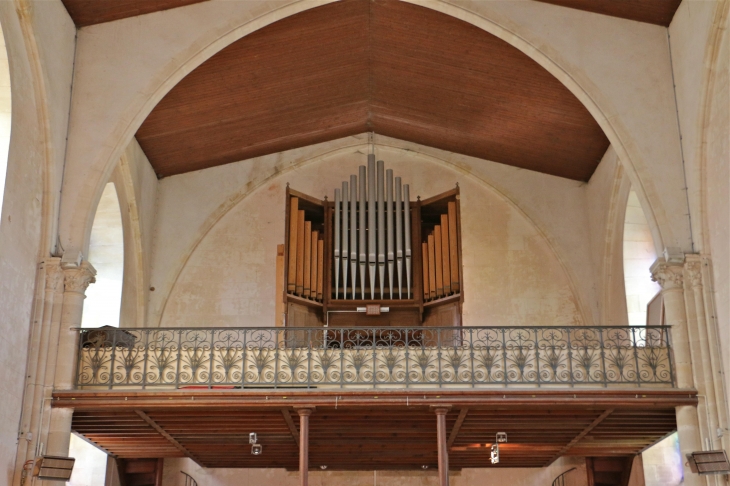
[60,0,682,270]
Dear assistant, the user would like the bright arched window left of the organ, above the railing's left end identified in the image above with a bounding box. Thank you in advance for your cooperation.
[81,182,124,327]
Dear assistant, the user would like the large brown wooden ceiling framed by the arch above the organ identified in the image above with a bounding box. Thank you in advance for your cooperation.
[137,0,609,181]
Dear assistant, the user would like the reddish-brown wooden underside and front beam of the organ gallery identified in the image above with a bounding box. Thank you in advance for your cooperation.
[53,389,696,470]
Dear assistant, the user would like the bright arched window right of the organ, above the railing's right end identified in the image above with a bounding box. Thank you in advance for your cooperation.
[623,189,660,326]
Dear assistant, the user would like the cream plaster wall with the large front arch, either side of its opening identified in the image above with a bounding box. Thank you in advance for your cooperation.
[61,0,690,266]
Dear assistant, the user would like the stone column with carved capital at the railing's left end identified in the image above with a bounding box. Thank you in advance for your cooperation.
[46,261,96,456]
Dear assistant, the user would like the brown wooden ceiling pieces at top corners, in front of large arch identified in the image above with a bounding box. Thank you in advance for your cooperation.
[63,0,682,27]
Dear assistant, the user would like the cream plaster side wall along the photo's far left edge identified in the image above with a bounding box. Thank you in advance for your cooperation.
[0,0,75,484]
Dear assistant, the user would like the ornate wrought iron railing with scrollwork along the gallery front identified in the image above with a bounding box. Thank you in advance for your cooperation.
[76,326,674,388]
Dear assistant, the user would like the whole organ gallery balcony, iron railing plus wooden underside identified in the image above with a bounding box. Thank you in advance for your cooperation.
[52,326,697,470]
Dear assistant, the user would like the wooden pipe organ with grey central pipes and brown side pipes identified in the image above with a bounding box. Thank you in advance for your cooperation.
[283,155,464,328]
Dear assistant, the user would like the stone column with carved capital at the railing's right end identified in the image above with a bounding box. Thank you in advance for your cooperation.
[651,258,707,486]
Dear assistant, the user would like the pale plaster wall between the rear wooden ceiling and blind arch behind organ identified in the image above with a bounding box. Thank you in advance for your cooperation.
[148,134,598,326]
